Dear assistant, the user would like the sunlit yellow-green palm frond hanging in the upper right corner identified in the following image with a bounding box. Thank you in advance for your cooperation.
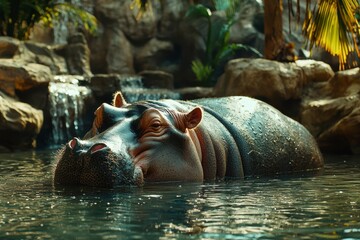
[303,0,360,69]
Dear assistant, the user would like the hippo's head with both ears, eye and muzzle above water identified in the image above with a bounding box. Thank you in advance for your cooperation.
[54,92,203,187]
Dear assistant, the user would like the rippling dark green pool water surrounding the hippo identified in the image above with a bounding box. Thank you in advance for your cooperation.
[0,152,360,239]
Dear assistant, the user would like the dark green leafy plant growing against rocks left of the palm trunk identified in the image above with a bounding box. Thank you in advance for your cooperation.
[185,0,261,85]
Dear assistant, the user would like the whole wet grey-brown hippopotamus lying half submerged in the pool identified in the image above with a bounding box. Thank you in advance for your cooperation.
[53,92,324,187]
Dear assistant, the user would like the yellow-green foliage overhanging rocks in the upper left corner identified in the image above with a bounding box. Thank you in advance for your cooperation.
[0,0,97,40]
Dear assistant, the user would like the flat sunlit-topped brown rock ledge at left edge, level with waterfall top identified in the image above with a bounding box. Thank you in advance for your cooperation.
[0,59,53,96]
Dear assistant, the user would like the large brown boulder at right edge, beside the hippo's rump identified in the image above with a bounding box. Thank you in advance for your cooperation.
[301,68,360,154]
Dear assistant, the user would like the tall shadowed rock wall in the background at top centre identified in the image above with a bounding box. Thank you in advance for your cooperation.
[76,0,264,87]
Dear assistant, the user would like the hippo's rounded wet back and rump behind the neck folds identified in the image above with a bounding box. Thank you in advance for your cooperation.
[193,97,323,176]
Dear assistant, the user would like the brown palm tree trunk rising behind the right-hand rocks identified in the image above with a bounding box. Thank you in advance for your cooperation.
[264,0,284,59]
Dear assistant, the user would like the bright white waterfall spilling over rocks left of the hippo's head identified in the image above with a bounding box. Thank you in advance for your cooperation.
[49,76,91,145]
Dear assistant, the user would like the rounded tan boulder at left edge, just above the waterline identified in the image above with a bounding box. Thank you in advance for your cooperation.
[0,92,43,149]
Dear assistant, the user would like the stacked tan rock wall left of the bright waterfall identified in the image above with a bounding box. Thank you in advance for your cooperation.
[0,34,91,149]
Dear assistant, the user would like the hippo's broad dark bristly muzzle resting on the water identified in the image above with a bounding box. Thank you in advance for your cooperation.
[54,140,143,187]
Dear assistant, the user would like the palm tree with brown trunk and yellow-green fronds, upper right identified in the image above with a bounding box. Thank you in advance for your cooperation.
[264,0,360,69]
